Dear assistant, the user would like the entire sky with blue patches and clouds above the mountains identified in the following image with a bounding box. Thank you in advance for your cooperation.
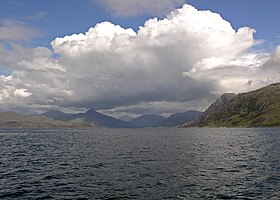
[0,0,280,117]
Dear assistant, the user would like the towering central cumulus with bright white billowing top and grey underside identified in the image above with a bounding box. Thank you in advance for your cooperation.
[49,5,254,108]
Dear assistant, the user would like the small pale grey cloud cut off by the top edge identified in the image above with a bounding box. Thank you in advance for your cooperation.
[90,0,185,17]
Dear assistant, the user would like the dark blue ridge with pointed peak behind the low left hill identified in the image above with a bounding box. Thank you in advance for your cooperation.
[42,109,132,128]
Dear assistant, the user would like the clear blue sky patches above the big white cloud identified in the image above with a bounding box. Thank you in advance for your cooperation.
[0,0,280,50]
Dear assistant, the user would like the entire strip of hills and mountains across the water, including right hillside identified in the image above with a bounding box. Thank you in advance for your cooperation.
[3,83,280,128]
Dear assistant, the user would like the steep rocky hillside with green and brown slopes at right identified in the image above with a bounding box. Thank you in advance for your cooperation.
[191,83,280,127]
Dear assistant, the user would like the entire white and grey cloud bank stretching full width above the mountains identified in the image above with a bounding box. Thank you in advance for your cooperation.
[0,5,280,114]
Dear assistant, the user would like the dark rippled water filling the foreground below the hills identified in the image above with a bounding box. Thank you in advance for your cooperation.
[0,129,280,199]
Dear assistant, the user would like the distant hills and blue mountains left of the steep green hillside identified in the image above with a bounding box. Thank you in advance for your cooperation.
[0,109,201,128]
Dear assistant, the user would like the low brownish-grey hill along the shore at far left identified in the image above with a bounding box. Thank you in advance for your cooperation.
[0,112,94,128]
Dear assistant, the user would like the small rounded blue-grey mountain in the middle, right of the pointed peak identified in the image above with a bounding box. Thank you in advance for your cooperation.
[129,114,166,128]
